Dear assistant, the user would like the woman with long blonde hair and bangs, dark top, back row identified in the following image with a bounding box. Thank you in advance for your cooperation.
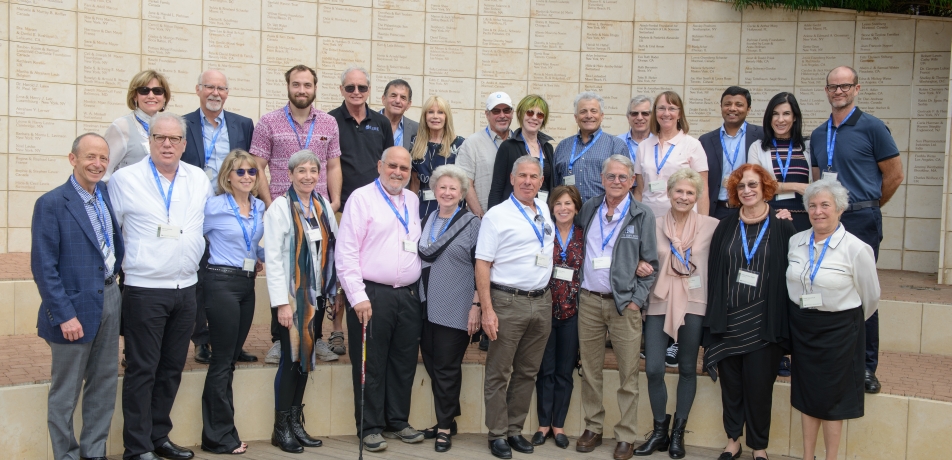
[410,96,465,218]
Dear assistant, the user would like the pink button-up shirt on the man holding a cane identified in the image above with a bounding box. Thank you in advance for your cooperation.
[334,182,421,305]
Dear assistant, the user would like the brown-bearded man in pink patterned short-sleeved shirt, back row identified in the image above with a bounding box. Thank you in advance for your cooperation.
[249,65,341,364]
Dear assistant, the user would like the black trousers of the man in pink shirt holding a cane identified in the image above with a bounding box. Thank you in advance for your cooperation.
[347,281,423,436]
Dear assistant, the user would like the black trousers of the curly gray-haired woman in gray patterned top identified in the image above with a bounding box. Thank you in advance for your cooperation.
[420,319,469,430]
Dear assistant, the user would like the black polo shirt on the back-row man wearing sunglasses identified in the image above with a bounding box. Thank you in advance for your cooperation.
[327,103,393,210]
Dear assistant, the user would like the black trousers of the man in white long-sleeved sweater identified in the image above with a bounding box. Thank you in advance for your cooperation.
[122,284,195,458]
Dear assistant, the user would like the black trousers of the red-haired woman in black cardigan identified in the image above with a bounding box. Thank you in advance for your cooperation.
[717,343,783,450]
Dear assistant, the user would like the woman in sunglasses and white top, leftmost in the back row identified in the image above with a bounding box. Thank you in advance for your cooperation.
[103,70,172,181]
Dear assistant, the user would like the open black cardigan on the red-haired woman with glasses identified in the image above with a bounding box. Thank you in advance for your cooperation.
[701,207,797,348]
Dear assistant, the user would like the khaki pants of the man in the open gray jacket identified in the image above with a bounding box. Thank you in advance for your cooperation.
[578,291,641,443]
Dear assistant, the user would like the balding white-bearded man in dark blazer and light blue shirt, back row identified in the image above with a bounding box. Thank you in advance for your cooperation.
[182,69,258,364]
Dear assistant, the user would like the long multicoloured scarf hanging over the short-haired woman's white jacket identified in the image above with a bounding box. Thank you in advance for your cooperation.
[285,187,337,372]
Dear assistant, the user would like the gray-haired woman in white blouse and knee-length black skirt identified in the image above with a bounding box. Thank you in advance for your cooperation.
[787,179,879,459]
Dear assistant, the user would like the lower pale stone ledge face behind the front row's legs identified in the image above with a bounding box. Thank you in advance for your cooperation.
[0,364,952,460]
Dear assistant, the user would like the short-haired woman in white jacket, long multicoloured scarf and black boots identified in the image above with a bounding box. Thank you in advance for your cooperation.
[264,150,341,453]
